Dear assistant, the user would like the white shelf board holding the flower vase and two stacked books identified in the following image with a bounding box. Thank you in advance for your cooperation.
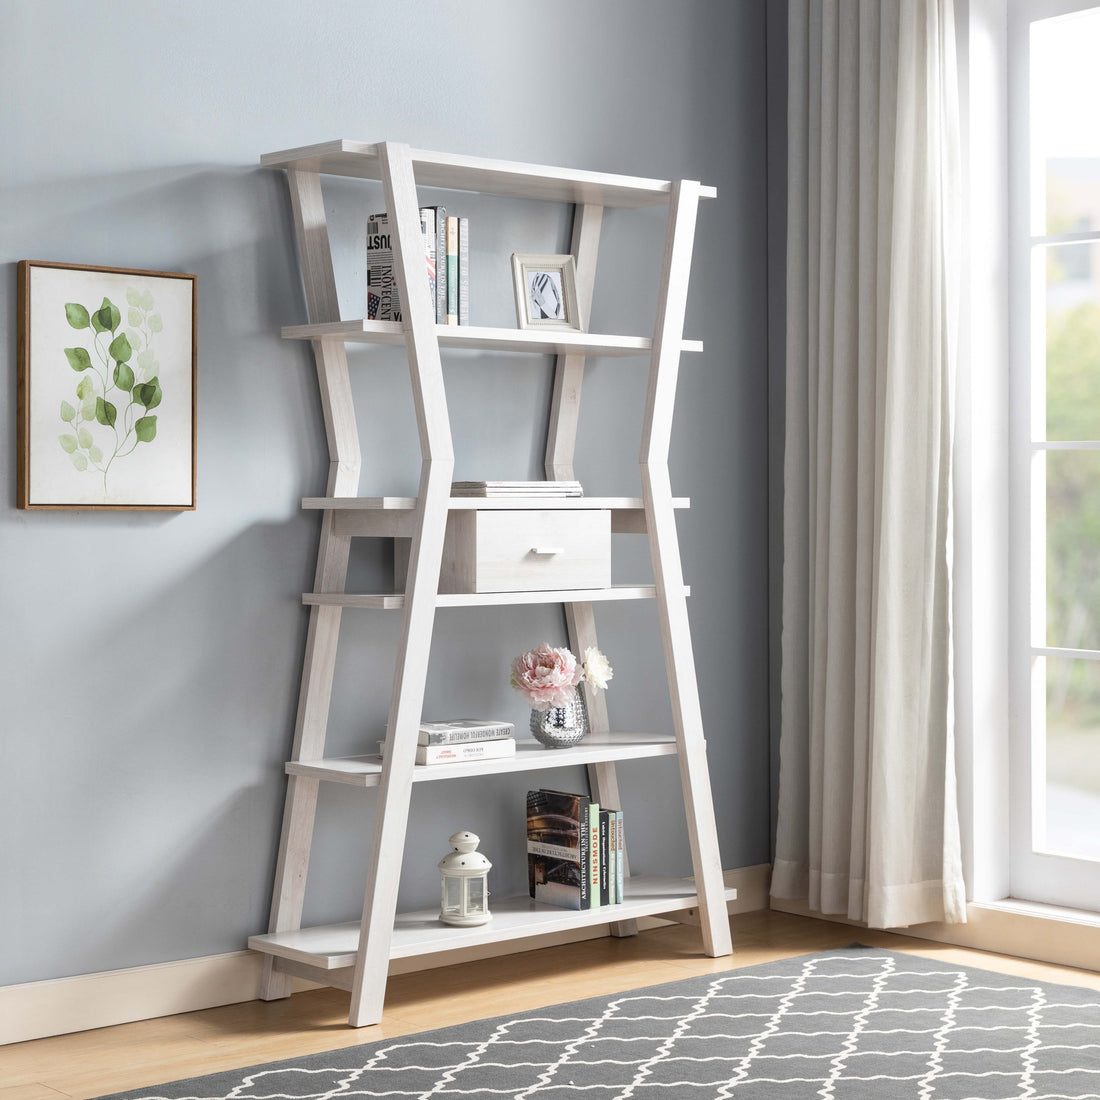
[286,733,677,787]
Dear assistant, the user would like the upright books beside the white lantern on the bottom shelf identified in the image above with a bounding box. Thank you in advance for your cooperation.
[527,790,624,910]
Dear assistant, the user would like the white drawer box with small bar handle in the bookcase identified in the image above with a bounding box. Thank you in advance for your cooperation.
[439,508,612,593]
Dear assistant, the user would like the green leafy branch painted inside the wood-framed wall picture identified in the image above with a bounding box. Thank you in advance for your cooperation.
[57,286,164,492]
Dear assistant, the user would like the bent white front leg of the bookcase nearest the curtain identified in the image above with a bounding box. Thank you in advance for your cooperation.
[639,180,733,957]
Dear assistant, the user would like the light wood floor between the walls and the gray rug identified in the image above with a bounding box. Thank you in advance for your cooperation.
[0,911,1100,1100]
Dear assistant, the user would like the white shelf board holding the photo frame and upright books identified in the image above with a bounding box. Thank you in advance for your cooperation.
[283,320,703,358]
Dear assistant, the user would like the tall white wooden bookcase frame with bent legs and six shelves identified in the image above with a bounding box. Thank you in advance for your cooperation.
[249,141,736,1026]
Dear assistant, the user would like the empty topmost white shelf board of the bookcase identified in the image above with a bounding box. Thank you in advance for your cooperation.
[260,139,718,209]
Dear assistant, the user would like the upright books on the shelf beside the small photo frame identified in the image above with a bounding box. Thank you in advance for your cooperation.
[366,207,470,325]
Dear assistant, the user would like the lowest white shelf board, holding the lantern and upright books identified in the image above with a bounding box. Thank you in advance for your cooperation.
[249,875,737,970]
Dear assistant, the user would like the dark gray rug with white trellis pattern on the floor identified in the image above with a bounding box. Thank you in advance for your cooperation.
[101,947,1100,1100]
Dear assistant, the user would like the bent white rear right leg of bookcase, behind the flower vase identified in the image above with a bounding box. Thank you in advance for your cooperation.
[546,204,638,936]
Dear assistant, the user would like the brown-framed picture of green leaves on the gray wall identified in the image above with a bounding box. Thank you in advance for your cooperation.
[17,260,196,510]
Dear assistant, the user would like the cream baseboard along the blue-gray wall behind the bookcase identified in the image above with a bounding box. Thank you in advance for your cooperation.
[0,864,771,1045]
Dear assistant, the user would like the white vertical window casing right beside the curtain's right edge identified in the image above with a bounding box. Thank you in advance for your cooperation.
[953,0,1011,905]
